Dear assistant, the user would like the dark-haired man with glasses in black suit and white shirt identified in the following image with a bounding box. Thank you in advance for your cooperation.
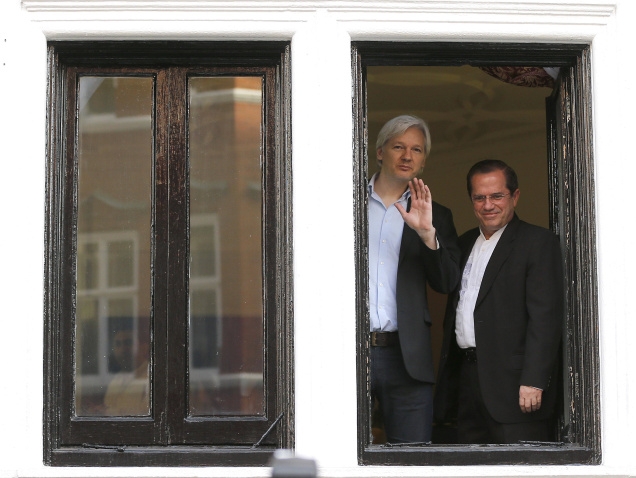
[435,160,563,444]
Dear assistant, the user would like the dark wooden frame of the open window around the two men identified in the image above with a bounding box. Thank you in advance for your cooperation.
[352,42,601,465]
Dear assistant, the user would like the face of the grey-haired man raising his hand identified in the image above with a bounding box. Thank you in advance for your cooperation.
[377,127,426,182]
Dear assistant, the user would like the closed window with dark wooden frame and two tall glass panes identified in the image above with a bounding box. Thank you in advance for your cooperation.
[45,42,293,466]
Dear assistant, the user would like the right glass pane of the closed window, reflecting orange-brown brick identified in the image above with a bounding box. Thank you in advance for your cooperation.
[188,77,264,416]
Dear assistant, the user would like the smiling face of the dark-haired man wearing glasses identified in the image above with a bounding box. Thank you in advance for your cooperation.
[471,171,519,239]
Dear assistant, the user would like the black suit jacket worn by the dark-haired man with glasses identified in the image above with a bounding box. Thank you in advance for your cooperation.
[435,215,563,423]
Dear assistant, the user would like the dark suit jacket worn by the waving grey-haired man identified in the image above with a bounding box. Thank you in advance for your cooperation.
[396,202,459,383]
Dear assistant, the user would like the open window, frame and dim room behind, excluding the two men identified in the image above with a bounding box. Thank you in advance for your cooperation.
[353,42,601,465]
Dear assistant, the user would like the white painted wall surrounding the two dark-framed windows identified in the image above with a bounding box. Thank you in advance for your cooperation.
[0,0,636,478]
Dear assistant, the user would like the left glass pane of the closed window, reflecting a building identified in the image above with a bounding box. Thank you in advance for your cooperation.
[75,77,154,416]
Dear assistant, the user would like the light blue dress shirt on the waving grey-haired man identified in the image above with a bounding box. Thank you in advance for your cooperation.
[369,174,411,332]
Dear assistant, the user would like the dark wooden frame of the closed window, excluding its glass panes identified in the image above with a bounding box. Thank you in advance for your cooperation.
[43,42,294,466]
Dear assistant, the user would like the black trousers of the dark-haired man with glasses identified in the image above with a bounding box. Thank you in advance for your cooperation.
[457,358,549,444]
